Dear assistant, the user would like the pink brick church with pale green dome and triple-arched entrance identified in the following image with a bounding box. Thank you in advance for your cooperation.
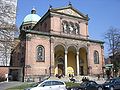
[10,4,104,79]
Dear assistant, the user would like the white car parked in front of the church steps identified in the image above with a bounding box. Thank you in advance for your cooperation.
[29,80,67,90]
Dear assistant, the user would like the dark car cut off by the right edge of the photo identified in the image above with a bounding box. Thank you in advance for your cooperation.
[103,77,120,90]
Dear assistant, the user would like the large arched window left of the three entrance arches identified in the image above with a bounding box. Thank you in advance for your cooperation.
[37,45,45,61]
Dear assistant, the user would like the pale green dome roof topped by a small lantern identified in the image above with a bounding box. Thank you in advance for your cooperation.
[23,8,41,23]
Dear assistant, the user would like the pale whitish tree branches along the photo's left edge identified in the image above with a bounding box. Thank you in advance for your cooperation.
[0,0,17,66]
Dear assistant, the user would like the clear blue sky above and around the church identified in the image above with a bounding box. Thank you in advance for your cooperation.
[16,0,120,56]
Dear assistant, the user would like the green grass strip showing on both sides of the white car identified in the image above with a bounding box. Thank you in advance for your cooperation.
[7,82,80,90]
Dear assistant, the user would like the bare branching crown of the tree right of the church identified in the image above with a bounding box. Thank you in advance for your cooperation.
[105,27,120,56]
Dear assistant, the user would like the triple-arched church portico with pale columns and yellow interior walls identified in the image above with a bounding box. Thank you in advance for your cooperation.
[54,44,88,76]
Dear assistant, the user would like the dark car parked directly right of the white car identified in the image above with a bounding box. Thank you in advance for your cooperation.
[67,81,103,90]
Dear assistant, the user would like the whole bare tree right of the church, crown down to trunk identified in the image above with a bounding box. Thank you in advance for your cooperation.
[105,27,120,76]
